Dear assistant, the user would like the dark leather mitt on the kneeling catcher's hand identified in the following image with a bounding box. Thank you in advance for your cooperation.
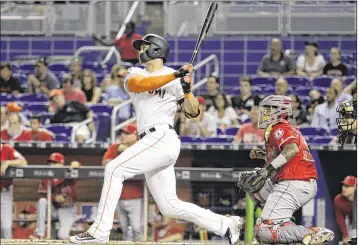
[236,168,269,194]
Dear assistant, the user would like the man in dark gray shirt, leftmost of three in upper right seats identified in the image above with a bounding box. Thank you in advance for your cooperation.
[257,38,295,77]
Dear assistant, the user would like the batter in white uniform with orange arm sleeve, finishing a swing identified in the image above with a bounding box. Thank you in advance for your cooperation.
[70,34,243,244]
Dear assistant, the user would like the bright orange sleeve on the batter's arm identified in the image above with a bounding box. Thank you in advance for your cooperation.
[124,69,175,93]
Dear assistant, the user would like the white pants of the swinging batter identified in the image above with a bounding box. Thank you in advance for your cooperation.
[88,125,231,241]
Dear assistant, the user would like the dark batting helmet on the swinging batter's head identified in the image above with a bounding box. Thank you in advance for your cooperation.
[133,34,169,63]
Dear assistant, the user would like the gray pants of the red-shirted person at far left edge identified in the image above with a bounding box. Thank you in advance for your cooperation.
[0,186,13,239]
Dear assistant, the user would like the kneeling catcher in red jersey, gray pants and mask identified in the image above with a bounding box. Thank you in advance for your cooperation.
[237,95,334,245]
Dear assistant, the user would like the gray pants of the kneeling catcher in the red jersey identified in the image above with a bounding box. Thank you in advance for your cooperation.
[255,179,317,244]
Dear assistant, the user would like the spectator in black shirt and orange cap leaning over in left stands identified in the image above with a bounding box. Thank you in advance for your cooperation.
[49,89,94,143]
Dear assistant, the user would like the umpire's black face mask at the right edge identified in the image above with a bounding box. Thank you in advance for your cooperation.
[336,101,357,145]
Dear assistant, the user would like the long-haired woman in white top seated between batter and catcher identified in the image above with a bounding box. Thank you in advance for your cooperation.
[208,93,239,129]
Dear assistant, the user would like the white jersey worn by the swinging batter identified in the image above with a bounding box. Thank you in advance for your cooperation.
[124,66,184,133]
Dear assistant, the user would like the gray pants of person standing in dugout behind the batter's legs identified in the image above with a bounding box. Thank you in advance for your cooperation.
[117,198,143,241]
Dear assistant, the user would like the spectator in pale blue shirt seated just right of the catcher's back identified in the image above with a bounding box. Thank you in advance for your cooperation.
[311,87,338,130]
